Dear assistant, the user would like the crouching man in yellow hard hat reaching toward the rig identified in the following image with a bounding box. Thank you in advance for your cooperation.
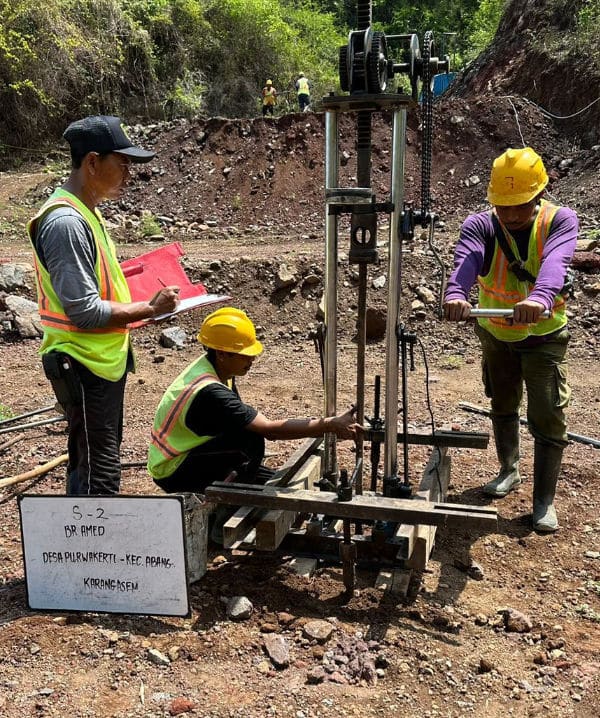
[148,307,362,540]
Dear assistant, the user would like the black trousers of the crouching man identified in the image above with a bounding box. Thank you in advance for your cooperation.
[155,431,275,494]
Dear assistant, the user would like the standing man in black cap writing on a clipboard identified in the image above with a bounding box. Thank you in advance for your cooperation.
[27,115,178,495]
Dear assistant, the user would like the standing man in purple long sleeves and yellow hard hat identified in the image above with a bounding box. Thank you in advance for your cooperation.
[444,147,578,532]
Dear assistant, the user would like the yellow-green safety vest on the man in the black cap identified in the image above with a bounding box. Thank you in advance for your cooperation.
[27,189,131,381]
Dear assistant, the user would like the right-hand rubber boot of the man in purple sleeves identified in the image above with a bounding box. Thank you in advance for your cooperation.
[533,441,563,533]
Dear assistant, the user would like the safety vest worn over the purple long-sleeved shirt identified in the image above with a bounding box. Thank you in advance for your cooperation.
[477,200,567,342]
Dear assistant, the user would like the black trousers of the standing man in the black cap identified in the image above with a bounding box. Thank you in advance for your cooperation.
[49,359,127,496]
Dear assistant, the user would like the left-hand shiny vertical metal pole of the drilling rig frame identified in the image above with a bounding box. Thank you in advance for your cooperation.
[323,110,339,483]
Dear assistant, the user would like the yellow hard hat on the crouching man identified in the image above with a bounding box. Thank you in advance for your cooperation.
[198,307,263,356]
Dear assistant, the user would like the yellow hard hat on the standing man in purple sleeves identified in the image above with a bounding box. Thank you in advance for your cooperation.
[487,147,548,207]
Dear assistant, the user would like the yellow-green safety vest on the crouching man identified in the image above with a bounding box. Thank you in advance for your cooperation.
[148,355,226,479]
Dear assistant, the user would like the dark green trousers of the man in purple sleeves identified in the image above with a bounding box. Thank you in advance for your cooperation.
[475,324,571,448]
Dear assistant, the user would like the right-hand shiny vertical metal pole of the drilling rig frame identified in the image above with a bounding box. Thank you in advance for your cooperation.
[383,109,406,479]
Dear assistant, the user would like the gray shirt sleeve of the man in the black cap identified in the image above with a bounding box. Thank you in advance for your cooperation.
[34,207,112,329]
